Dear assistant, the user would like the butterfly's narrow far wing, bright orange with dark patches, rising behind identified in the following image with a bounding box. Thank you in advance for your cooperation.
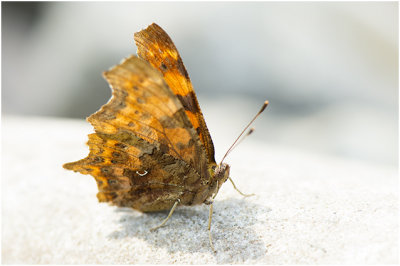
[134,23,215,164]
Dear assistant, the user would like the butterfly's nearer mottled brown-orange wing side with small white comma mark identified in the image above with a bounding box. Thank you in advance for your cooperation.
[64,56,211,211]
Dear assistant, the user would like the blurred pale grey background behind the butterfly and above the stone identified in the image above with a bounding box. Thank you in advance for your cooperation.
[2,2,398,167]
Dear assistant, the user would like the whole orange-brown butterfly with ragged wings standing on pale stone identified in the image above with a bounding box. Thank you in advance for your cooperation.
[63,23,267,250]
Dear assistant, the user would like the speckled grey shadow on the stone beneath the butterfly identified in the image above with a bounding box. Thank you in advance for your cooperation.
[108,196,271,263]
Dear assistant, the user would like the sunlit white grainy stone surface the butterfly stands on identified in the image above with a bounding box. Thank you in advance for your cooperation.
[1,117,399,264]
